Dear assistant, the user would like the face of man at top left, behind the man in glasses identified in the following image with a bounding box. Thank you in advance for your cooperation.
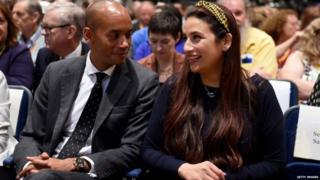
[12,1,38,34]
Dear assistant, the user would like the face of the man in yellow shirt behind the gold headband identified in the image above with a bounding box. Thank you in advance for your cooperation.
[220,0,247,27]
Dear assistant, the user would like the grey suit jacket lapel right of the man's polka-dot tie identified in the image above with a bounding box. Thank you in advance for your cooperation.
[93,60,130,137]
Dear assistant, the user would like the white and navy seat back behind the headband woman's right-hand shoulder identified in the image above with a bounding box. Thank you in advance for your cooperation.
[269,79,299,113]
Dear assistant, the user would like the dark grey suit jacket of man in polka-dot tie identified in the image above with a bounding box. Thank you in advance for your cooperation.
[14,56,159,179]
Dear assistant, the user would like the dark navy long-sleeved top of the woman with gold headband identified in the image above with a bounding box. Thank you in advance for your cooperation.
[141,75,285,180]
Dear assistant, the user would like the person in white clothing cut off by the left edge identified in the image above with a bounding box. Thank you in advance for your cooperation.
[0,71,17,180]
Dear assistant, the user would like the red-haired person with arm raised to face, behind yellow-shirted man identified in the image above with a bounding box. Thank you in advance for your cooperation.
[260,9,302,67]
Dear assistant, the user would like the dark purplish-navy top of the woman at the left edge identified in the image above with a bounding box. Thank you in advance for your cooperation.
[0,43,34,90]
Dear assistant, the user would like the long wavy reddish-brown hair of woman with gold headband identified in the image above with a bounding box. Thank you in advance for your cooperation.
[164,2,251,168]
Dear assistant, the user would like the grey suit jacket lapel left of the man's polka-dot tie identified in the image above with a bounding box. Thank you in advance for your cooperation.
[51,56,86,152]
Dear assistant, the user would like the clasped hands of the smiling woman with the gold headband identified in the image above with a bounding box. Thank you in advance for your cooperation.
[178,161,226,180]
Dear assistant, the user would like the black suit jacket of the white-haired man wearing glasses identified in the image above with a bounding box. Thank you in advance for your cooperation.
[33,43,90,90]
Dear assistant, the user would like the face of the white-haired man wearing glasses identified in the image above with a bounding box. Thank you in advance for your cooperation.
[41,10,70,55]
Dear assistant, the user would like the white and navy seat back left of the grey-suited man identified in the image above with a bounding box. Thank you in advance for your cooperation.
[8,85,32,139]
